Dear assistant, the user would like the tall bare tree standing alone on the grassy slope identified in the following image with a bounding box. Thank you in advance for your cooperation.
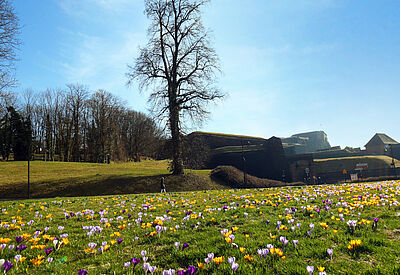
[127,0,224,174]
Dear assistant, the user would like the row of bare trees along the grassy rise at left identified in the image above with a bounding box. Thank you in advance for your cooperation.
[0,84,165,163]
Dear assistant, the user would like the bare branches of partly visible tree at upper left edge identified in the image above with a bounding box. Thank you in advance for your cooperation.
[0,0,20,92]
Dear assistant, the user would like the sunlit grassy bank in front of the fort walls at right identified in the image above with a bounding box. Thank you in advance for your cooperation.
[314,156,400,173]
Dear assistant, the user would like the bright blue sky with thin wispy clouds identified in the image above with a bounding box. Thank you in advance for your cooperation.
[12,0,400,147]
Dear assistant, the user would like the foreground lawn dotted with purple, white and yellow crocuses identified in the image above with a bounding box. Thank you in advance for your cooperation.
[0,181,400,274]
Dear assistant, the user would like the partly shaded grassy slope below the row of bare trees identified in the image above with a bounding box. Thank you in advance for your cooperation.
[0,161,224,198]
